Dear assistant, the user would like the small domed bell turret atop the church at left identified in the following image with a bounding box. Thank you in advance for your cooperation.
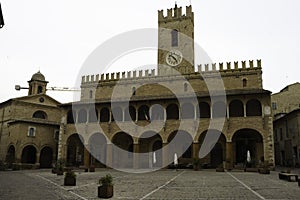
[28,71,48,95]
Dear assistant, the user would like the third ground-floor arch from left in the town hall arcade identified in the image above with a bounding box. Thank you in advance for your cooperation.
[112,132,133,168]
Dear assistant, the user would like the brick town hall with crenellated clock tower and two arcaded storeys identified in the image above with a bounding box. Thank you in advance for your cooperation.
[0,6,274,168]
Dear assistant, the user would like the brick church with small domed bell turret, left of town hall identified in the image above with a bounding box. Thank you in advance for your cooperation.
[0,72,61,168]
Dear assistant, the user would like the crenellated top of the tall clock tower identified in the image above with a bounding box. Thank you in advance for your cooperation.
[158,4,194,22]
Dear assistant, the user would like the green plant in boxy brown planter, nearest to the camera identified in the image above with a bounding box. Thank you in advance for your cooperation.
[98,174,114,198]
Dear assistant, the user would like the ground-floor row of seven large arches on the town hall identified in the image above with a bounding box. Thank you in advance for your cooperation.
[63,129,264,168]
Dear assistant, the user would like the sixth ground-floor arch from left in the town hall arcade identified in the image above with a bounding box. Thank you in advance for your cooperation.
[199,129,226,168]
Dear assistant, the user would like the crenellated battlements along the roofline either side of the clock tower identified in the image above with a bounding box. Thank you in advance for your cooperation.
[81,60,261,84]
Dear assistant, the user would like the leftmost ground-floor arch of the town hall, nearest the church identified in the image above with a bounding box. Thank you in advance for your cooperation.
[67,133,84,167]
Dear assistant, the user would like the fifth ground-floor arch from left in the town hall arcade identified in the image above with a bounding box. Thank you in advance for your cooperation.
[168,130,193,165]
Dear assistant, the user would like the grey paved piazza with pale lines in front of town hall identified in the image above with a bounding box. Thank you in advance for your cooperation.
[0,169,300,200]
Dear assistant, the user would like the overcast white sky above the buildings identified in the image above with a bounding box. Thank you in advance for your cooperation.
[0,0,300,102]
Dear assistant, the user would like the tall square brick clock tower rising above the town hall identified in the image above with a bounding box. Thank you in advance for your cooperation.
[158,4,194,75]
